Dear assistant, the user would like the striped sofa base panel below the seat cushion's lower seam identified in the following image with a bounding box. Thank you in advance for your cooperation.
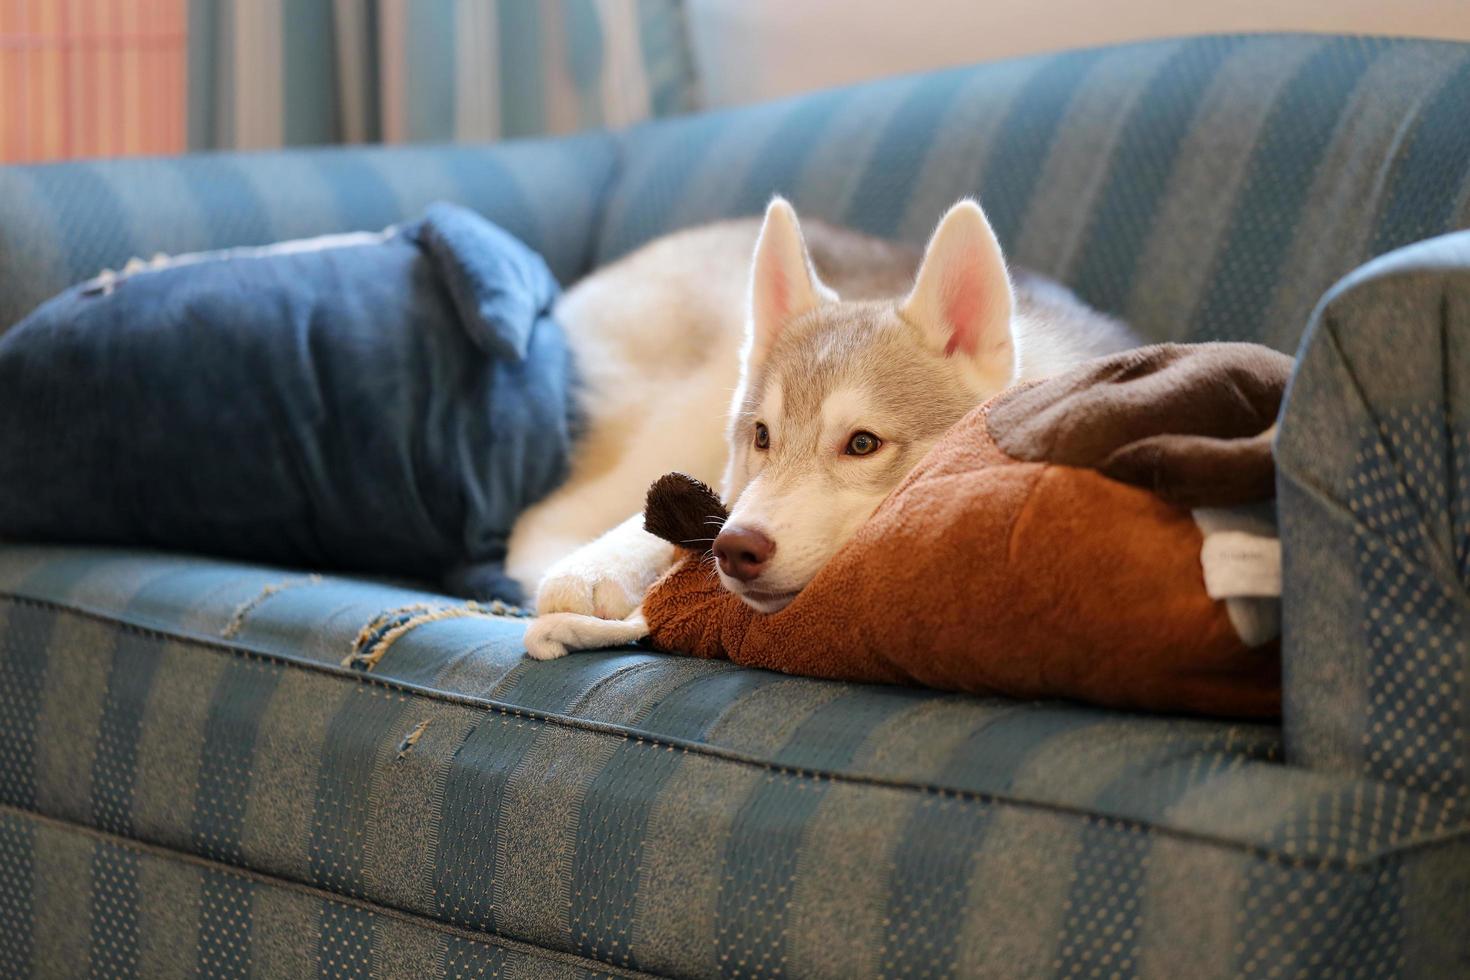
[0,807,623,980]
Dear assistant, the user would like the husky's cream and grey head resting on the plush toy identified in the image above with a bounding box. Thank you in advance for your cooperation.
[714,197,1016,613]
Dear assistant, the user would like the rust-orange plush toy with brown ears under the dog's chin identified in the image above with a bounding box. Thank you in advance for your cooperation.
[642,344,1291,717]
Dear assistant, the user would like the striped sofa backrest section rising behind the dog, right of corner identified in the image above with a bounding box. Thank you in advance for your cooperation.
[598,35,1470,350]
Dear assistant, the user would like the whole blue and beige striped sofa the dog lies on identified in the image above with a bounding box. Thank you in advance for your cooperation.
[0,37,1470,977]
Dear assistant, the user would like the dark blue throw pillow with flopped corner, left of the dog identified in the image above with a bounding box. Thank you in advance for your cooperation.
[0,204,572,601]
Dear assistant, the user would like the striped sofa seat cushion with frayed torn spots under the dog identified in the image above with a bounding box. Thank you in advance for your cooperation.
[0,547,1470,976]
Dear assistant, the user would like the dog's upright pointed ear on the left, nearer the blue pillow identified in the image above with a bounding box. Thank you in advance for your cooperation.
[745,197,836,363]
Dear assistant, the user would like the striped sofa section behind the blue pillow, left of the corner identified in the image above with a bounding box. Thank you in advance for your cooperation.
[0,134,616,332]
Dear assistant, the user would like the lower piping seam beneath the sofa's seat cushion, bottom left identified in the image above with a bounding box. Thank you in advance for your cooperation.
[0,804,663,977]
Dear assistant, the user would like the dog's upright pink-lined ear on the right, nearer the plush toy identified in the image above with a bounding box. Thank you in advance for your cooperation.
[900,198,1016,391]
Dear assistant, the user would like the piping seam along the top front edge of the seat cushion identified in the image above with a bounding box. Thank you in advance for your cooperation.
[0,592,1470,871]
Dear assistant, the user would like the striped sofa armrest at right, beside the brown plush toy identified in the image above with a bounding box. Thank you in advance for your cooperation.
[1277,232,1470,796]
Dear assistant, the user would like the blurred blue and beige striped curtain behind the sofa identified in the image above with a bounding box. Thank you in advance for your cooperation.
[188,0,695,150]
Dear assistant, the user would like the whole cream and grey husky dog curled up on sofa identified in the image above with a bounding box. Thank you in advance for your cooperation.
[507,198,1136,654]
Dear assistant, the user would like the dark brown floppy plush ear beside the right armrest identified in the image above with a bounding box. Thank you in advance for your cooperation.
[991,344,1292,507]
